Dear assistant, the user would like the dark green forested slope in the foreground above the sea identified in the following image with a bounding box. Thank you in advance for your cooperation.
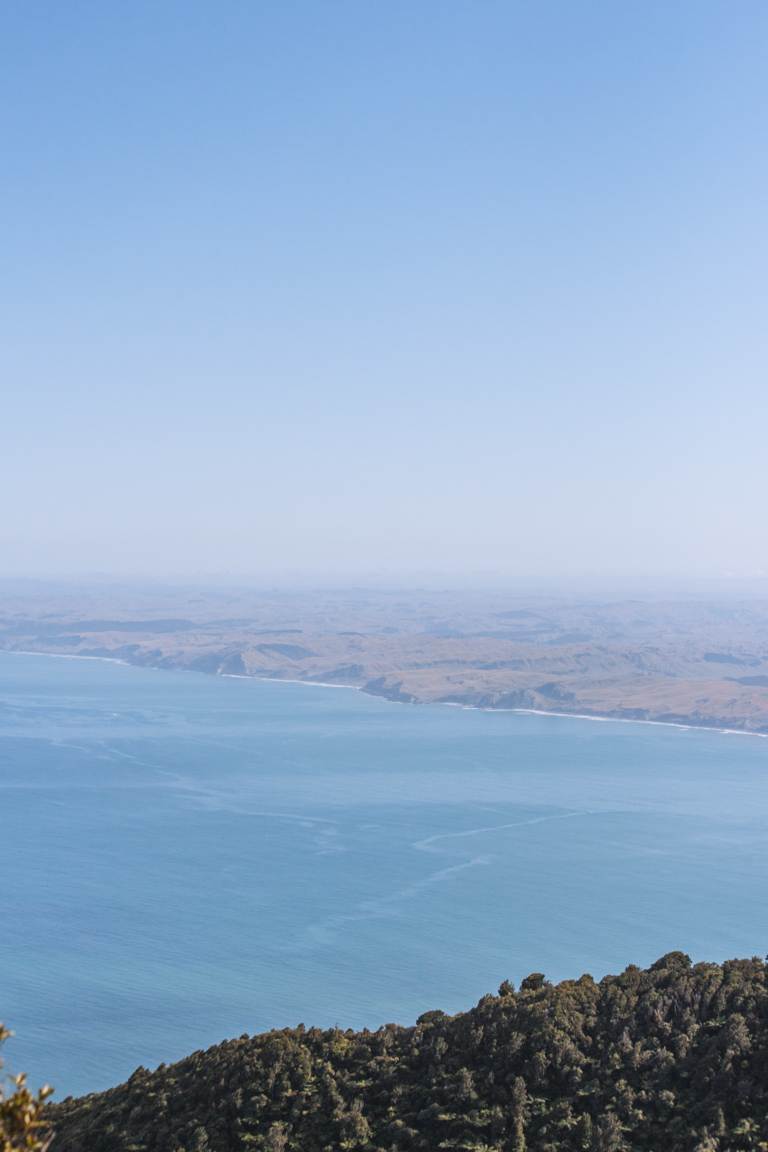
[48,953,768,1152]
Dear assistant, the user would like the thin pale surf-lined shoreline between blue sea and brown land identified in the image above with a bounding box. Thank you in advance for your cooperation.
[0,649,768,740]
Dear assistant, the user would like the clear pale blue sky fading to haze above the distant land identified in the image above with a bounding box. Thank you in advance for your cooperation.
[0,0,768,577]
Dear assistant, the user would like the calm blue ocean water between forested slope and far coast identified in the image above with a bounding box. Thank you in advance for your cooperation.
[0,653,768,1097]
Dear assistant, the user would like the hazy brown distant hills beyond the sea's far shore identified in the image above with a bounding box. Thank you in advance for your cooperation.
[0,585,768,734]
